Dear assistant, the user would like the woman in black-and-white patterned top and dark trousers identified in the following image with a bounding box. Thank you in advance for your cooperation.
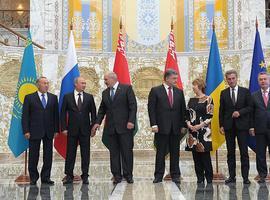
[186,78,213,184]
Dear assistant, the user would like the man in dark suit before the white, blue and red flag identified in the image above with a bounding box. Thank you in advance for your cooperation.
[61,77,96,184]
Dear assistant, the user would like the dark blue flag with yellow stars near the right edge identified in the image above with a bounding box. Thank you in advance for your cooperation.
[248,23,266,151]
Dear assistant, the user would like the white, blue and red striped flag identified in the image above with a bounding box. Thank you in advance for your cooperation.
[54,30,80,158]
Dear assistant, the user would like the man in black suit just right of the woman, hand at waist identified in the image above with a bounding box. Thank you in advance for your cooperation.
[219,70,251,184]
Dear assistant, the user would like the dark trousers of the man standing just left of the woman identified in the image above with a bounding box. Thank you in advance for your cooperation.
[154,133,180,179]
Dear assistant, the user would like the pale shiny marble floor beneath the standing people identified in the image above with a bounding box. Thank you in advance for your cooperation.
[0,152,270,200]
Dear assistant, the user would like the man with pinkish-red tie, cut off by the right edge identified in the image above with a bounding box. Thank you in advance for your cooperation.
[250,72,270,183]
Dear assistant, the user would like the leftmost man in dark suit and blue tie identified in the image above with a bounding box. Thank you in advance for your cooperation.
[22,77,59,185]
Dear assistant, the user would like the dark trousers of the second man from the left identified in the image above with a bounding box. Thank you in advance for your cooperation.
[65,132,90,179]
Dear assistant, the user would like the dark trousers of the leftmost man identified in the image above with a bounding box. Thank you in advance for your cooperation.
[28,136,53,181]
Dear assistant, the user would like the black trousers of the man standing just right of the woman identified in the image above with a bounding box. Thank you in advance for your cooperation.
[225,125,249,179]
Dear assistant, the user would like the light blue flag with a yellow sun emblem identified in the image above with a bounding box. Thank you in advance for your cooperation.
[8,31,37,157]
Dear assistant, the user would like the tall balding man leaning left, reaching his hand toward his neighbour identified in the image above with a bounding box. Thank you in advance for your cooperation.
[92,72,137,184]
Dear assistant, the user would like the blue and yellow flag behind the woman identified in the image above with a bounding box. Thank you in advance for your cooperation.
[206,28,225,151]
